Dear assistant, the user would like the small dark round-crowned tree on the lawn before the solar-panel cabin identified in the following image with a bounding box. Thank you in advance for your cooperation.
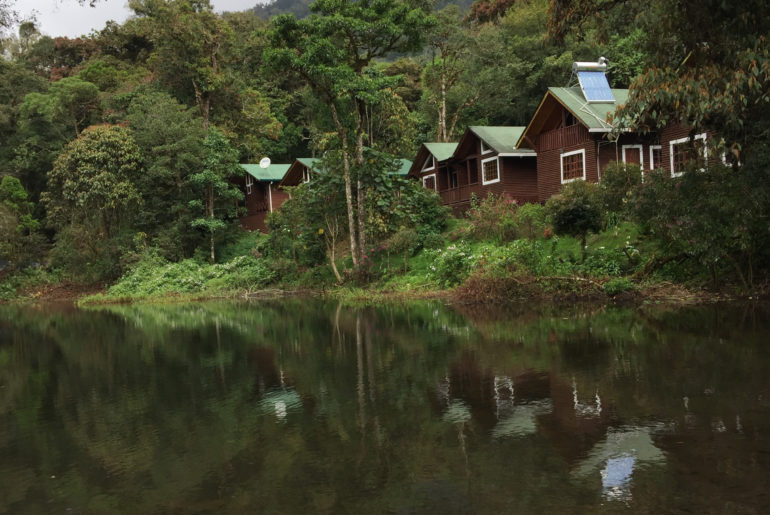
[545,181,603,259]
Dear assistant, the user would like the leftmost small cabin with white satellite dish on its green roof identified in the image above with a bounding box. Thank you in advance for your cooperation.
[239,164,289,232]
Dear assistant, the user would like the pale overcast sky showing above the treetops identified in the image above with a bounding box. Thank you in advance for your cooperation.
[11,0,268,38]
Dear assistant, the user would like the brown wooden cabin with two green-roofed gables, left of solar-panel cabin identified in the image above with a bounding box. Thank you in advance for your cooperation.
[409,125,537,215]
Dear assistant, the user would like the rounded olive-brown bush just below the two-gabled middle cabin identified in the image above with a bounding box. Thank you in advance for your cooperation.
[465,193,519,243]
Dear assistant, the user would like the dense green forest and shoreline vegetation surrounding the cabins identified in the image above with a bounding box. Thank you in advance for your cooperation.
[0,0,770,297]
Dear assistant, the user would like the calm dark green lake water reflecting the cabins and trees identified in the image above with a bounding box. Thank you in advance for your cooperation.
[0,299,770,514]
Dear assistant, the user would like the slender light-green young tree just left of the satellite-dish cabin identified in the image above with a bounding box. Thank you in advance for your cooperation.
[187,127,243,264]
